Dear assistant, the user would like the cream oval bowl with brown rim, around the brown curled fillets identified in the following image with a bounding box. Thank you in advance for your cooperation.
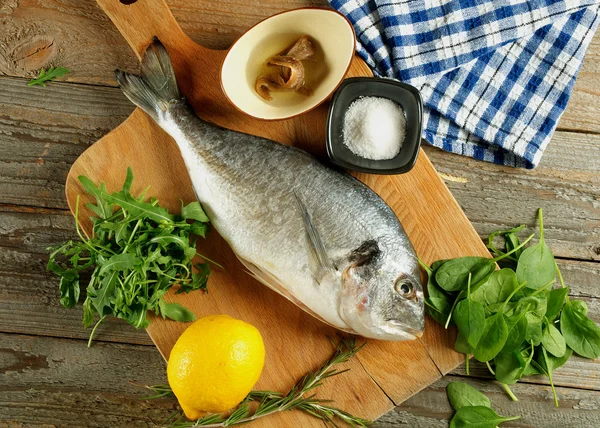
[221,8,355,120]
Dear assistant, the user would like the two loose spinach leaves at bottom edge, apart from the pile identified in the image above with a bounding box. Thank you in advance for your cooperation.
[446,382,520,428]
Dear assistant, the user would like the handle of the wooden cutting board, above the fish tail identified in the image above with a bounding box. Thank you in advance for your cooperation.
[96,0,205,59]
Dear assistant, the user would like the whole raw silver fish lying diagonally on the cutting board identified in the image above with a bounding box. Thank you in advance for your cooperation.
[116,40,424,340]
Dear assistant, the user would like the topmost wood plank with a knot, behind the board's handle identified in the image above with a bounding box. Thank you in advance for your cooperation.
[0,0,600,132]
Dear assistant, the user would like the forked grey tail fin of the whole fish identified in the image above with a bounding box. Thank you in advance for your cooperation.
[115,37,181,121]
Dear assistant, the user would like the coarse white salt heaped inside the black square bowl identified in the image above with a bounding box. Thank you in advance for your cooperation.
[343,97,406,160]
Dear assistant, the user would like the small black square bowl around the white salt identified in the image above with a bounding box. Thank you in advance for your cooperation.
[327,77,423,174]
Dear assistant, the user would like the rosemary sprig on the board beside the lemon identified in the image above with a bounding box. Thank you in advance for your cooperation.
[146,339,370,428]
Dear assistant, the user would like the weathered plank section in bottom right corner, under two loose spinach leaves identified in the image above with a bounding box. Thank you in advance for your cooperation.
[375,376,600,428]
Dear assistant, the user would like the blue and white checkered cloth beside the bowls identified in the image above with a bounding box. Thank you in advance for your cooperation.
[330,0,600,168]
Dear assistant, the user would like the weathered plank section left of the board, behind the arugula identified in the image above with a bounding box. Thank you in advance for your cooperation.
[0,206,152,345]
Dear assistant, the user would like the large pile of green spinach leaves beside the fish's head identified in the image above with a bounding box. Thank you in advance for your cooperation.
[421,209,600,406]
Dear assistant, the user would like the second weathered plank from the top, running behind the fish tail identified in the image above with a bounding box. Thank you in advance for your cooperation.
[0,78,600,260]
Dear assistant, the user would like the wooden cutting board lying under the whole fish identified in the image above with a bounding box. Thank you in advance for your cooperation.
[66,0,489,427]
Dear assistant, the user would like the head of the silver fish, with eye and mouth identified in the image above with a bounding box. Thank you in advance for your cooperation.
[339,241,425,341]
